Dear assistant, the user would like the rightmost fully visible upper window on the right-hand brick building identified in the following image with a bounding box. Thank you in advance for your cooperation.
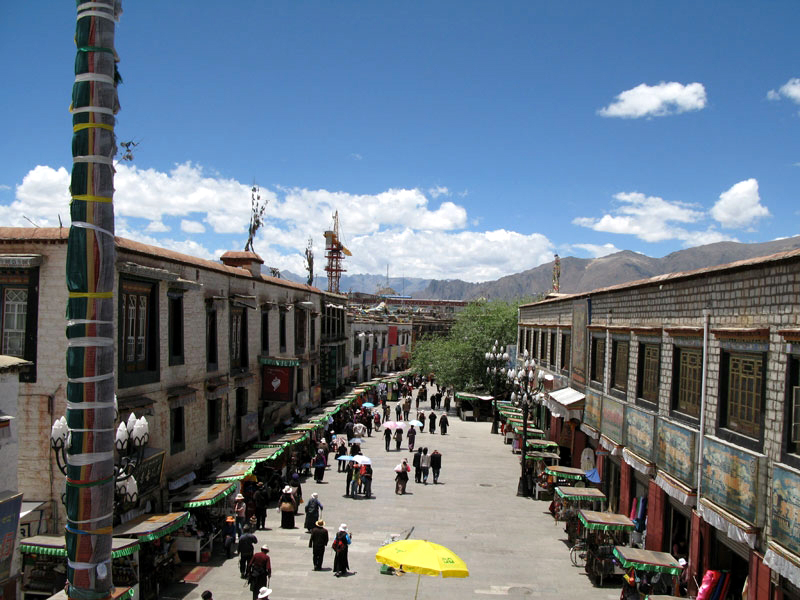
[720,352,765,438]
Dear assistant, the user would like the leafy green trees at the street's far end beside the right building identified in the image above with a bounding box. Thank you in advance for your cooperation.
[411,300,531,391]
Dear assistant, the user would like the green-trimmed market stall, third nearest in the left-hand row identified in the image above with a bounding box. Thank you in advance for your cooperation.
[169,482,236,563]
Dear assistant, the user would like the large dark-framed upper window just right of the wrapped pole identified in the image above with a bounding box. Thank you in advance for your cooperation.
[119,279,159,387]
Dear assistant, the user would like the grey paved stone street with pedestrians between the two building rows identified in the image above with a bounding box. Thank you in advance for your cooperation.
[162,394,619,600]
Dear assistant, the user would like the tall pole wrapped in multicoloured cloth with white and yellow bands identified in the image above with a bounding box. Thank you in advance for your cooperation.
[65,0,122,600]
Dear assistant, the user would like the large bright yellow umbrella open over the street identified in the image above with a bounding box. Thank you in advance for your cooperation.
[375,540,469,598]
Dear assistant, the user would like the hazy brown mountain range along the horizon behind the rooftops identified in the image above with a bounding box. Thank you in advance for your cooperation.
[282,236,800,300]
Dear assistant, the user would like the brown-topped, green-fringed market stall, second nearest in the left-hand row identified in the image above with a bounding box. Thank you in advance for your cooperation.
[114,512,189,600]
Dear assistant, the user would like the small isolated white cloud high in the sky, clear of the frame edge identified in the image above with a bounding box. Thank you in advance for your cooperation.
[597,81,706,119]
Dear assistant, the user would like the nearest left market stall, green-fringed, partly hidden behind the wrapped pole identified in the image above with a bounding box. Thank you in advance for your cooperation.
[19,534,140,600]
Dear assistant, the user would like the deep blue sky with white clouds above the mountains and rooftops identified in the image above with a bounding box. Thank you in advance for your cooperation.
[0,0,800,281]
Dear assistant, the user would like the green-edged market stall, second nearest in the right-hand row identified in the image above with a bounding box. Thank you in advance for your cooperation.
[578,510,634,586]
